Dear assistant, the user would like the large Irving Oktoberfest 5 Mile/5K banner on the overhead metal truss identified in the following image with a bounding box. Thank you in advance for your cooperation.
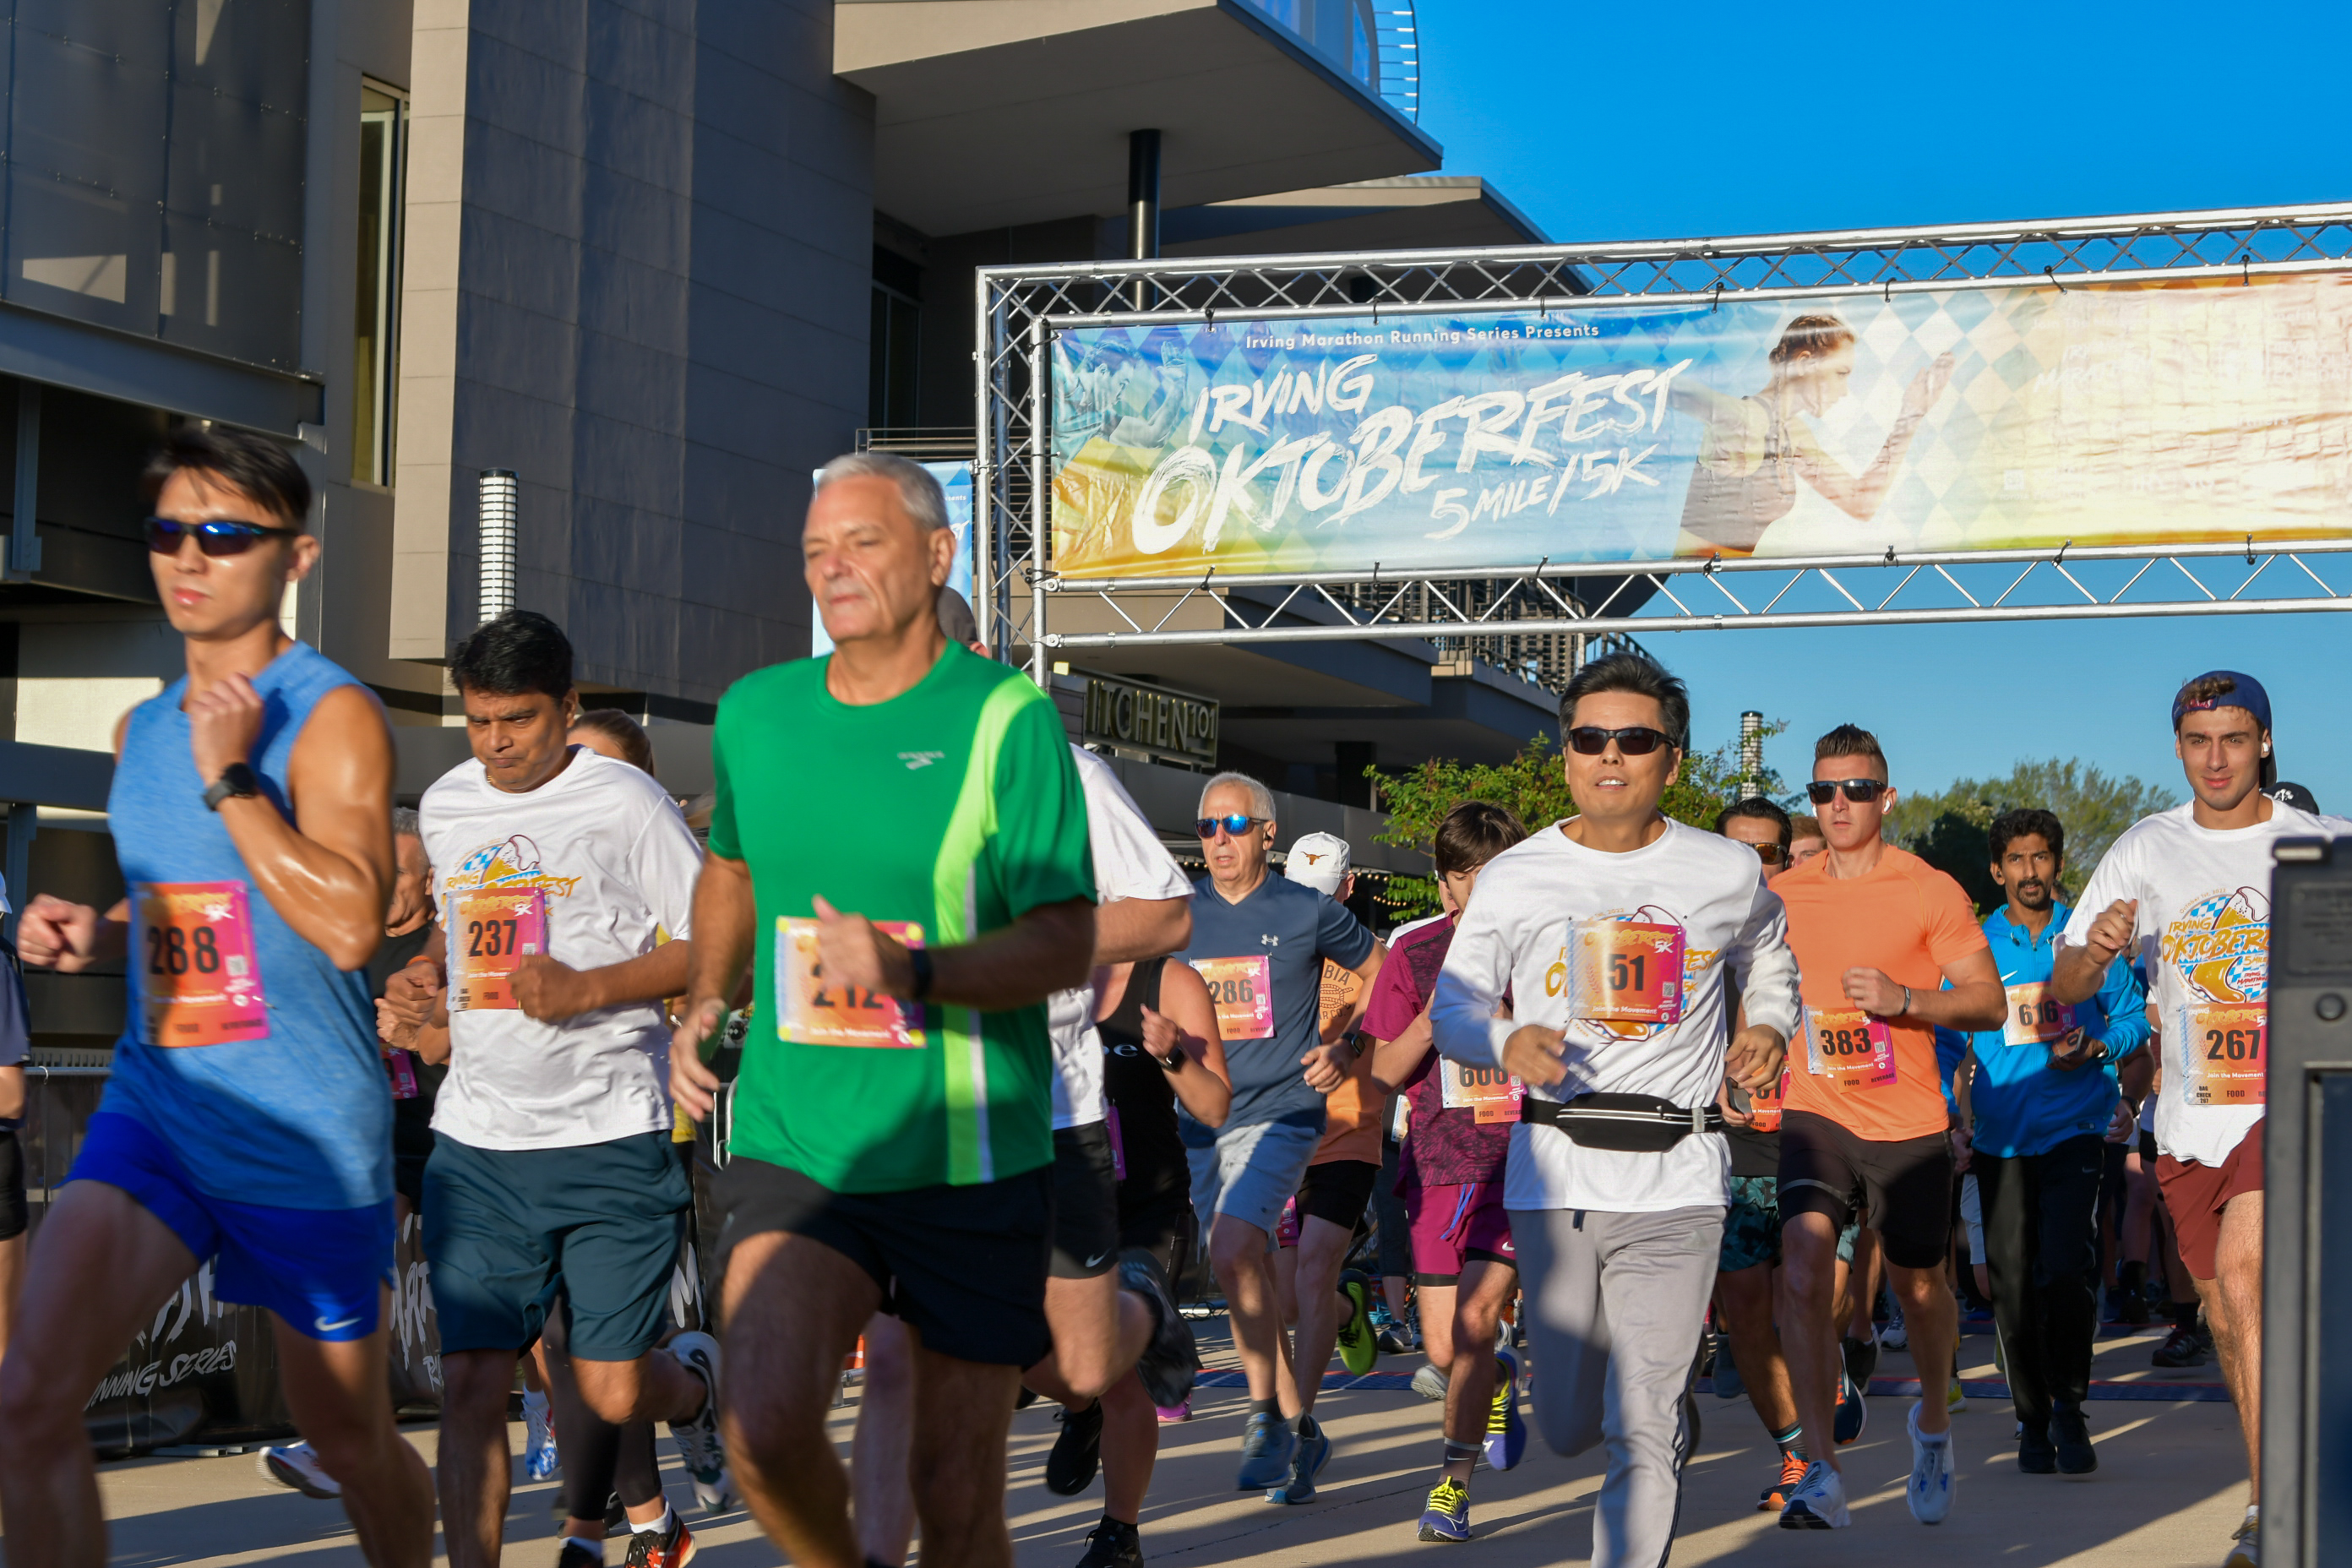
[1051,273,2352,579]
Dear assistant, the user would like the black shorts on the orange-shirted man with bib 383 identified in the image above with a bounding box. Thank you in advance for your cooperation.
[1780,1109,1952,1270]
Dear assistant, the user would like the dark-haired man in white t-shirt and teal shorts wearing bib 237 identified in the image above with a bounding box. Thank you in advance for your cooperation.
[419,611,727,1568]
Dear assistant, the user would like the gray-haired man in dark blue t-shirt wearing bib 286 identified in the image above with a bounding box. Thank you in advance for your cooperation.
[1176,773,1380,1502]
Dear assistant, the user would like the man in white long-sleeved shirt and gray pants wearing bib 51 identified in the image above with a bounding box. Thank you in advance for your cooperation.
[1430,654,1797,1568]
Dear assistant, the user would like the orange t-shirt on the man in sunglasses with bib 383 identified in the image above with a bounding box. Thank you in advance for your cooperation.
[1771,844,1990,1142]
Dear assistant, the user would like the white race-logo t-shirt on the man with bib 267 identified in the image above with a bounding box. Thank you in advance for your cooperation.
[2063,802,2352,1166]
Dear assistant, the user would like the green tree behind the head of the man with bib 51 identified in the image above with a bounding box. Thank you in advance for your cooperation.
[1371,724,1780,919]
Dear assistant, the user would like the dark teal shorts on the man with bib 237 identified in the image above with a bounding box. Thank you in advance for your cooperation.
[423,1133,694,1361]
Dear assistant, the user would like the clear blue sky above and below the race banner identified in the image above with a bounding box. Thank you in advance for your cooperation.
[1418,0,2352,811]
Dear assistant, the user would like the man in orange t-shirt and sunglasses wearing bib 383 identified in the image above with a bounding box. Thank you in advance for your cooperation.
[1773,724,2009,1530]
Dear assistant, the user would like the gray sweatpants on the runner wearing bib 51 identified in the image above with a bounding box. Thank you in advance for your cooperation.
[1510,1206,1724,1568]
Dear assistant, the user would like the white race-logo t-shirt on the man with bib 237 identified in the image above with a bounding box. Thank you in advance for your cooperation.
[416,748,703,1150]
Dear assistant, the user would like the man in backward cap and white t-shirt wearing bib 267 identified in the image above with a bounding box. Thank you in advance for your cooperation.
[2051,670,2352,1568]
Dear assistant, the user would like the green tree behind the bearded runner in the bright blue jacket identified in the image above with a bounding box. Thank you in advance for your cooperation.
[1886,757,2180,912]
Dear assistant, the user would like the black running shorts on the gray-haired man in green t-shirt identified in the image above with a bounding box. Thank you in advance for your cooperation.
[713,1154,1054,1366]
